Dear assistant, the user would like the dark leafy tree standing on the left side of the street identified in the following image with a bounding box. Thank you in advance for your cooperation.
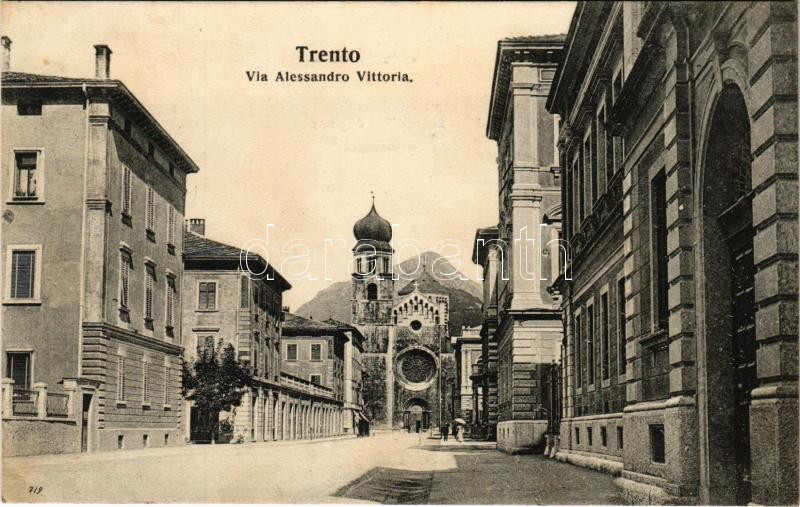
[182,339,252,442]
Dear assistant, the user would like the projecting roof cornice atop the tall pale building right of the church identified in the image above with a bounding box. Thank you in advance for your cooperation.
[486,34,565,140]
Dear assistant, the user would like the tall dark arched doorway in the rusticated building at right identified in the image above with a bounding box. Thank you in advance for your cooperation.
[698,84,757,505]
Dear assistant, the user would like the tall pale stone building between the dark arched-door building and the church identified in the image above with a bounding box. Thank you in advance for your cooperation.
[476,35,563,452]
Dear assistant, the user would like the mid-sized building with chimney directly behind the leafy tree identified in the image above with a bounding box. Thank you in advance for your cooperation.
[182,224,291,442]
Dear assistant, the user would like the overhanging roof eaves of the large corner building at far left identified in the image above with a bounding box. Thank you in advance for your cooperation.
[1,71,200,173]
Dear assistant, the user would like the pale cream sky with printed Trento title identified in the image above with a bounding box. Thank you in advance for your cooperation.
[0,2,575,308]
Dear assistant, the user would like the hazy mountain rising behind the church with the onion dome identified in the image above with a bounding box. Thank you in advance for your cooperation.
[292,252,482,336]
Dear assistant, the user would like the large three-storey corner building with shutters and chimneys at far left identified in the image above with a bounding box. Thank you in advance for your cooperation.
[1,41,198,456]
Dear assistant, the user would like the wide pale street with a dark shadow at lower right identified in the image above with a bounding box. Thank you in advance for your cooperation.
[3,434,621,504]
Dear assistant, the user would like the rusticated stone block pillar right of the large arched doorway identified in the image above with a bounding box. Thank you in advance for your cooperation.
[748,2,798,505]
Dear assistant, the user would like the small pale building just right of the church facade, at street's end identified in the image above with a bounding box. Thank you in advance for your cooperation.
[450,327,485,438]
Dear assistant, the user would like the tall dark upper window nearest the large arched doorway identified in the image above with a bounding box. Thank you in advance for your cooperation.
[650,171,669,329]
